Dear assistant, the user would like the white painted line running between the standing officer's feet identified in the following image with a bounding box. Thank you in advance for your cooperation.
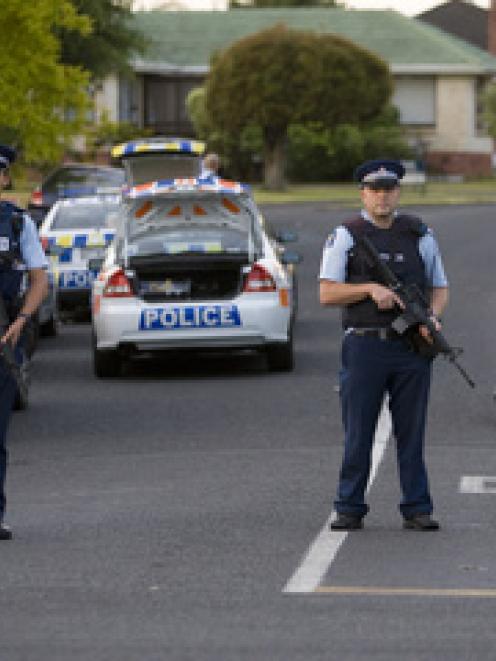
[283,402,392,594]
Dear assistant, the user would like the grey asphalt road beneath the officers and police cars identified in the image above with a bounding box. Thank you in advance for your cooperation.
[0,204,496,661]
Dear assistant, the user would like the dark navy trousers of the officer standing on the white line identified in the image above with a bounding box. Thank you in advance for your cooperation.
[334,333,432,516]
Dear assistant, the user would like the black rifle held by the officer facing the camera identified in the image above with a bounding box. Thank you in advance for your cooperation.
[359,236,475,388]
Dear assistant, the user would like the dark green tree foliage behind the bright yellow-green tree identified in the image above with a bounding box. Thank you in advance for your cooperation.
[56,0,145,79]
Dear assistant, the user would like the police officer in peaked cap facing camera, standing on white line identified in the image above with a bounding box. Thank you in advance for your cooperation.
[320,159,448,530]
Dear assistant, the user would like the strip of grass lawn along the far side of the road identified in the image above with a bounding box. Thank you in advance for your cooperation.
[8,179,496,206]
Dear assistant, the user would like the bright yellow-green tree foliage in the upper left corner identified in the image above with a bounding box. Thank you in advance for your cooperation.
[0,0,91,162]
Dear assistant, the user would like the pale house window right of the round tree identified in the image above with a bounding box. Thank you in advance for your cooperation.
[392,77,436,126]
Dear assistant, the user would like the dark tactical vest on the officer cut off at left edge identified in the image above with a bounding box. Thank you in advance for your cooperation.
[0,200,24,318]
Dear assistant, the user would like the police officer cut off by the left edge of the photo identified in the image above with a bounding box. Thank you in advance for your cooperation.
[0,145,47,540]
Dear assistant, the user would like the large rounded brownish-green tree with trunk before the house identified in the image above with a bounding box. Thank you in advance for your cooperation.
[206,25,393,188]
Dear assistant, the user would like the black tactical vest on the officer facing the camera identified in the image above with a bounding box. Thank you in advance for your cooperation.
[343,214,427,328]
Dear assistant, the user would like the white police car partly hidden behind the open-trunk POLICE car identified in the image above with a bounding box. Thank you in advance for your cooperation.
[40,195,121,313]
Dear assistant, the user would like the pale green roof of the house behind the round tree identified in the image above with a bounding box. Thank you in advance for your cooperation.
[134,8,496,73]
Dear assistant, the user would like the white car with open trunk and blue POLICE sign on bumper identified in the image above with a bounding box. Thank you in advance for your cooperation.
[92,178,293,377]
